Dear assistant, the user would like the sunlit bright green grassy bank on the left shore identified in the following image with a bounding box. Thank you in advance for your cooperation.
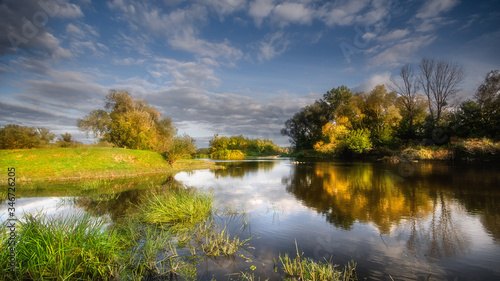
[0,147,219,182]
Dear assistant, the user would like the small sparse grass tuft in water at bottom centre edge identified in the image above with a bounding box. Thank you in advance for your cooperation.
[279,243,358,281]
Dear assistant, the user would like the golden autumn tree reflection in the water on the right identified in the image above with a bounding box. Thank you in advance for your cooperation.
[282,162,500,259]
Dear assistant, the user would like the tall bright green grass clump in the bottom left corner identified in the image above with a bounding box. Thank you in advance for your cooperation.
[0,213,120,280]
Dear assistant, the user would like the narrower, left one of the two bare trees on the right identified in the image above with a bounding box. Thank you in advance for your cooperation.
[388,64,419,127]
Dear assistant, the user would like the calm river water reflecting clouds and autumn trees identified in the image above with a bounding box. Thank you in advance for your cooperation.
[0,159,500,280]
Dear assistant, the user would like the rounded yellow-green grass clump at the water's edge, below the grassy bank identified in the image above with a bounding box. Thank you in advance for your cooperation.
[141,187,213,230]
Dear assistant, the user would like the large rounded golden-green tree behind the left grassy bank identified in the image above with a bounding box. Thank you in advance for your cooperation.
[77,90,176,152]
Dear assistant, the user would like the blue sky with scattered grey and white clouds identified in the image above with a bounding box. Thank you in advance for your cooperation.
[0,0,500,147]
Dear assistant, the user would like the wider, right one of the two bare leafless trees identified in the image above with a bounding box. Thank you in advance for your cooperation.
[418,58,465,124]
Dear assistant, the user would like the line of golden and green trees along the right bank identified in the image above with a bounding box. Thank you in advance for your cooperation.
[281,58,500,154]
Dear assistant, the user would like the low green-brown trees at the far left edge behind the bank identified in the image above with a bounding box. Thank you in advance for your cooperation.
[0,124,41,149]
